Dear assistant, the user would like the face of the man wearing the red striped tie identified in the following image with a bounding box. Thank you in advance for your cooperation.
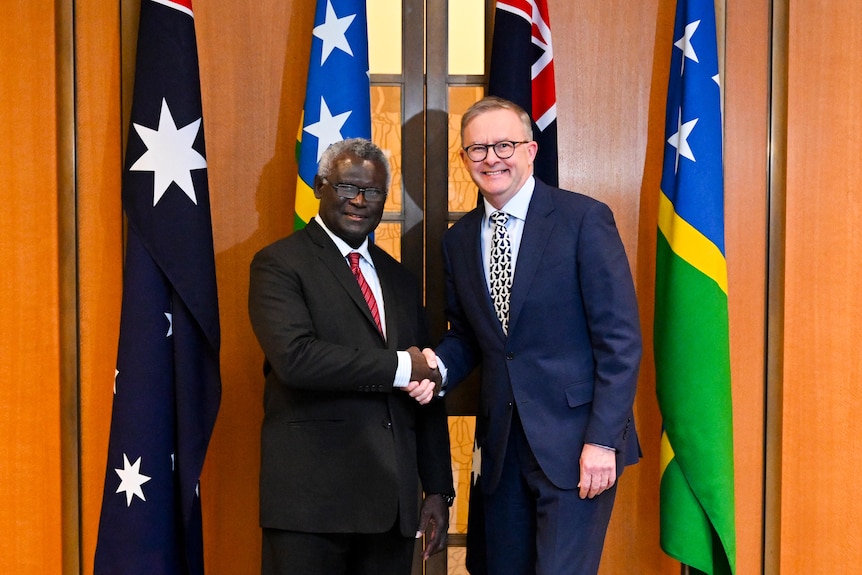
[314,151,386,248]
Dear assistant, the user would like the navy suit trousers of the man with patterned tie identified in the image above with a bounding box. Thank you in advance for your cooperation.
[484,411,616,575]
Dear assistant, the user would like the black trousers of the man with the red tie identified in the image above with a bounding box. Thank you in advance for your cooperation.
[261,521,416,575]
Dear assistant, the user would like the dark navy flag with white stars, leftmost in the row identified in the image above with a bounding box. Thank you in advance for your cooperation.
[94,0,221,575]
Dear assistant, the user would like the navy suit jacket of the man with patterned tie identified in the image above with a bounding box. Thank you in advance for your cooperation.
[436,180,641,492]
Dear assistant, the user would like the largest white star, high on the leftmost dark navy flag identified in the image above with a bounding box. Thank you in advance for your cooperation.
[129,98,207,206]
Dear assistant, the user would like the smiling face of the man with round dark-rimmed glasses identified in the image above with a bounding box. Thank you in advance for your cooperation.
[461,109,538,209]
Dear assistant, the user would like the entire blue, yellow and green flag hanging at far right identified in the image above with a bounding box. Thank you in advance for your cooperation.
[654,0,736,575]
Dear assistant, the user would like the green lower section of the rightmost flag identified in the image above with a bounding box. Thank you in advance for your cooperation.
[654,233,736,574]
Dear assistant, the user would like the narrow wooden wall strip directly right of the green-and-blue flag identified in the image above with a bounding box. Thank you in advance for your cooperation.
[723,0,770,574]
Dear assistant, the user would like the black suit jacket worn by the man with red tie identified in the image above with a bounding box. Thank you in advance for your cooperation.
[249,221,452,537]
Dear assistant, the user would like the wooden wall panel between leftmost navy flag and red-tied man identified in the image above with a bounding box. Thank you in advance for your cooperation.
[195,1,318,575]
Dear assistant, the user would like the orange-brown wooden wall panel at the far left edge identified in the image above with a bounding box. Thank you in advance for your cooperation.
[0,2,62,575]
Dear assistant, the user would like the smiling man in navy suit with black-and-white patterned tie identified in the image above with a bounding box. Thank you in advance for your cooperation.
[424,97,641,575]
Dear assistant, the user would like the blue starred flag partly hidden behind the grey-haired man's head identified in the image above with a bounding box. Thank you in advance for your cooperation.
[294,0,371,230]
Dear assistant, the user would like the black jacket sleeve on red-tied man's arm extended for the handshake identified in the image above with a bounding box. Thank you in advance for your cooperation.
[249,243,398,392]
